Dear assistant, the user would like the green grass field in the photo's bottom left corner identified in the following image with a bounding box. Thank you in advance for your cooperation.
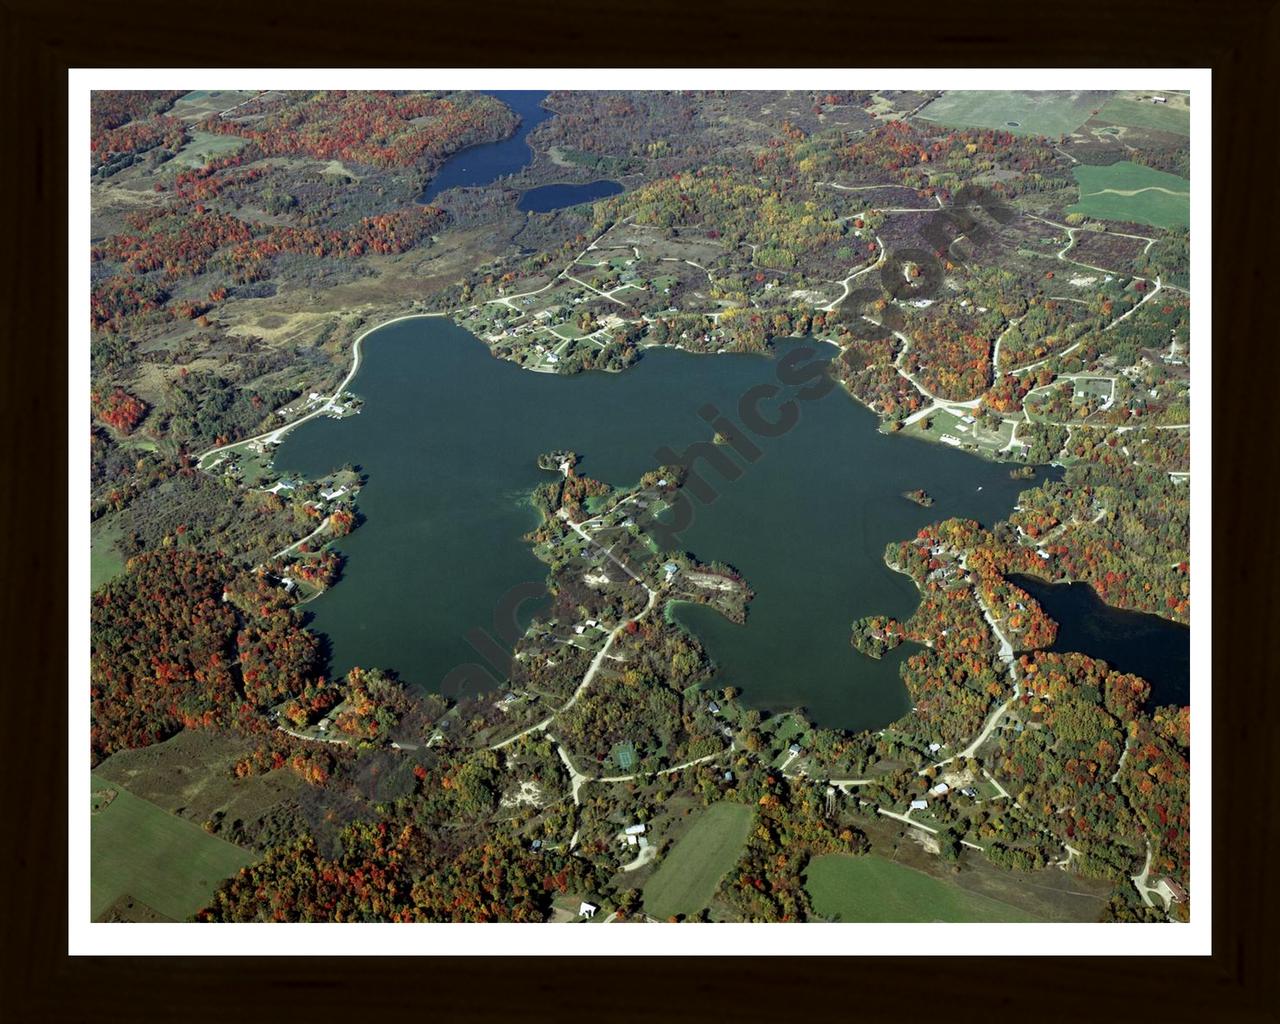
[90,776,253,920]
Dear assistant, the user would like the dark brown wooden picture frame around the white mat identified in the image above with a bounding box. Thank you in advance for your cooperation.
[0,0,1280,1021]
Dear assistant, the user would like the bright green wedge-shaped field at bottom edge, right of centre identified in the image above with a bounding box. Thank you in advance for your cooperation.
[805,854,1036,923]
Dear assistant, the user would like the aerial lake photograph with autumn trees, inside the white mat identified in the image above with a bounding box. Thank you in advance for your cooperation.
[85,83,1192,936]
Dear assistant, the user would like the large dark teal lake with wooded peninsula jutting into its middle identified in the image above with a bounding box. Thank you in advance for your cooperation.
[275,319,1054,730]
